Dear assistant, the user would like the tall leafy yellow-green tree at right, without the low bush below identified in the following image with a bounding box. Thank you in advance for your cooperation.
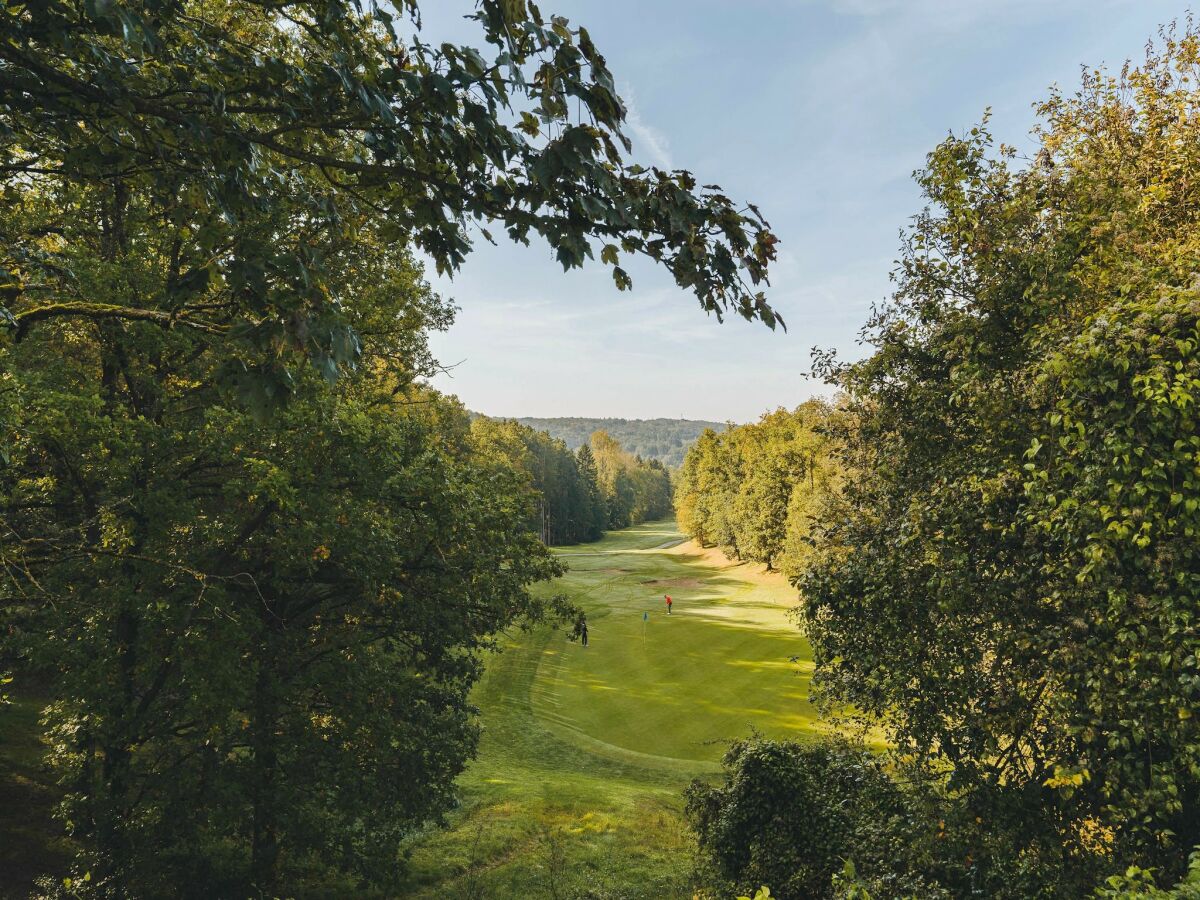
[802,25,1200,895]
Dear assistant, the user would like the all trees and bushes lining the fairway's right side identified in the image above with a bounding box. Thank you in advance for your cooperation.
[679,22,1200,900]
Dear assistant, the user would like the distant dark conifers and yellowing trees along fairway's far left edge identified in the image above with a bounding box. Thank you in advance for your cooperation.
[472,416,671,545]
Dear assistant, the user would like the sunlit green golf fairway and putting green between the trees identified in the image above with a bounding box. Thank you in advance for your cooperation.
[403,521,821,898]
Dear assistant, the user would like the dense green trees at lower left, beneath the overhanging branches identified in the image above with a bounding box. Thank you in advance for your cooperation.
[0,225,557,895]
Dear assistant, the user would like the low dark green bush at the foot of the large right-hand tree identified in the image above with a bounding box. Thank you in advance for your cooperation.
[686,737,1104,900]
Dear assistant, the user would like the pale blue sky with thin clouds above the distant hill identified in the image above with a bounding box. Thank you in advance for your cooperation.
[422,0,1187,422]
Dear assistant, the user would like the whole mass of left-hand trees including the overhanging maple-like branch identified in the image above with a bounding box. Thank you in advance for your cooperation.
[0,0,776,898]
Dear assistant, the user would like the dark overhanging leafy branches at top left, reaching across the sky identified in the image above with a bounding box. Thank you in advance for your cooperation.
[0,0,778,415]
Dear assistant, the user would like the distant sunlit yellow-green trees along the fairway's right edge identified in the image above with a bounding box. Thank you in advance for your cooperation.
[674,400,839,575]
